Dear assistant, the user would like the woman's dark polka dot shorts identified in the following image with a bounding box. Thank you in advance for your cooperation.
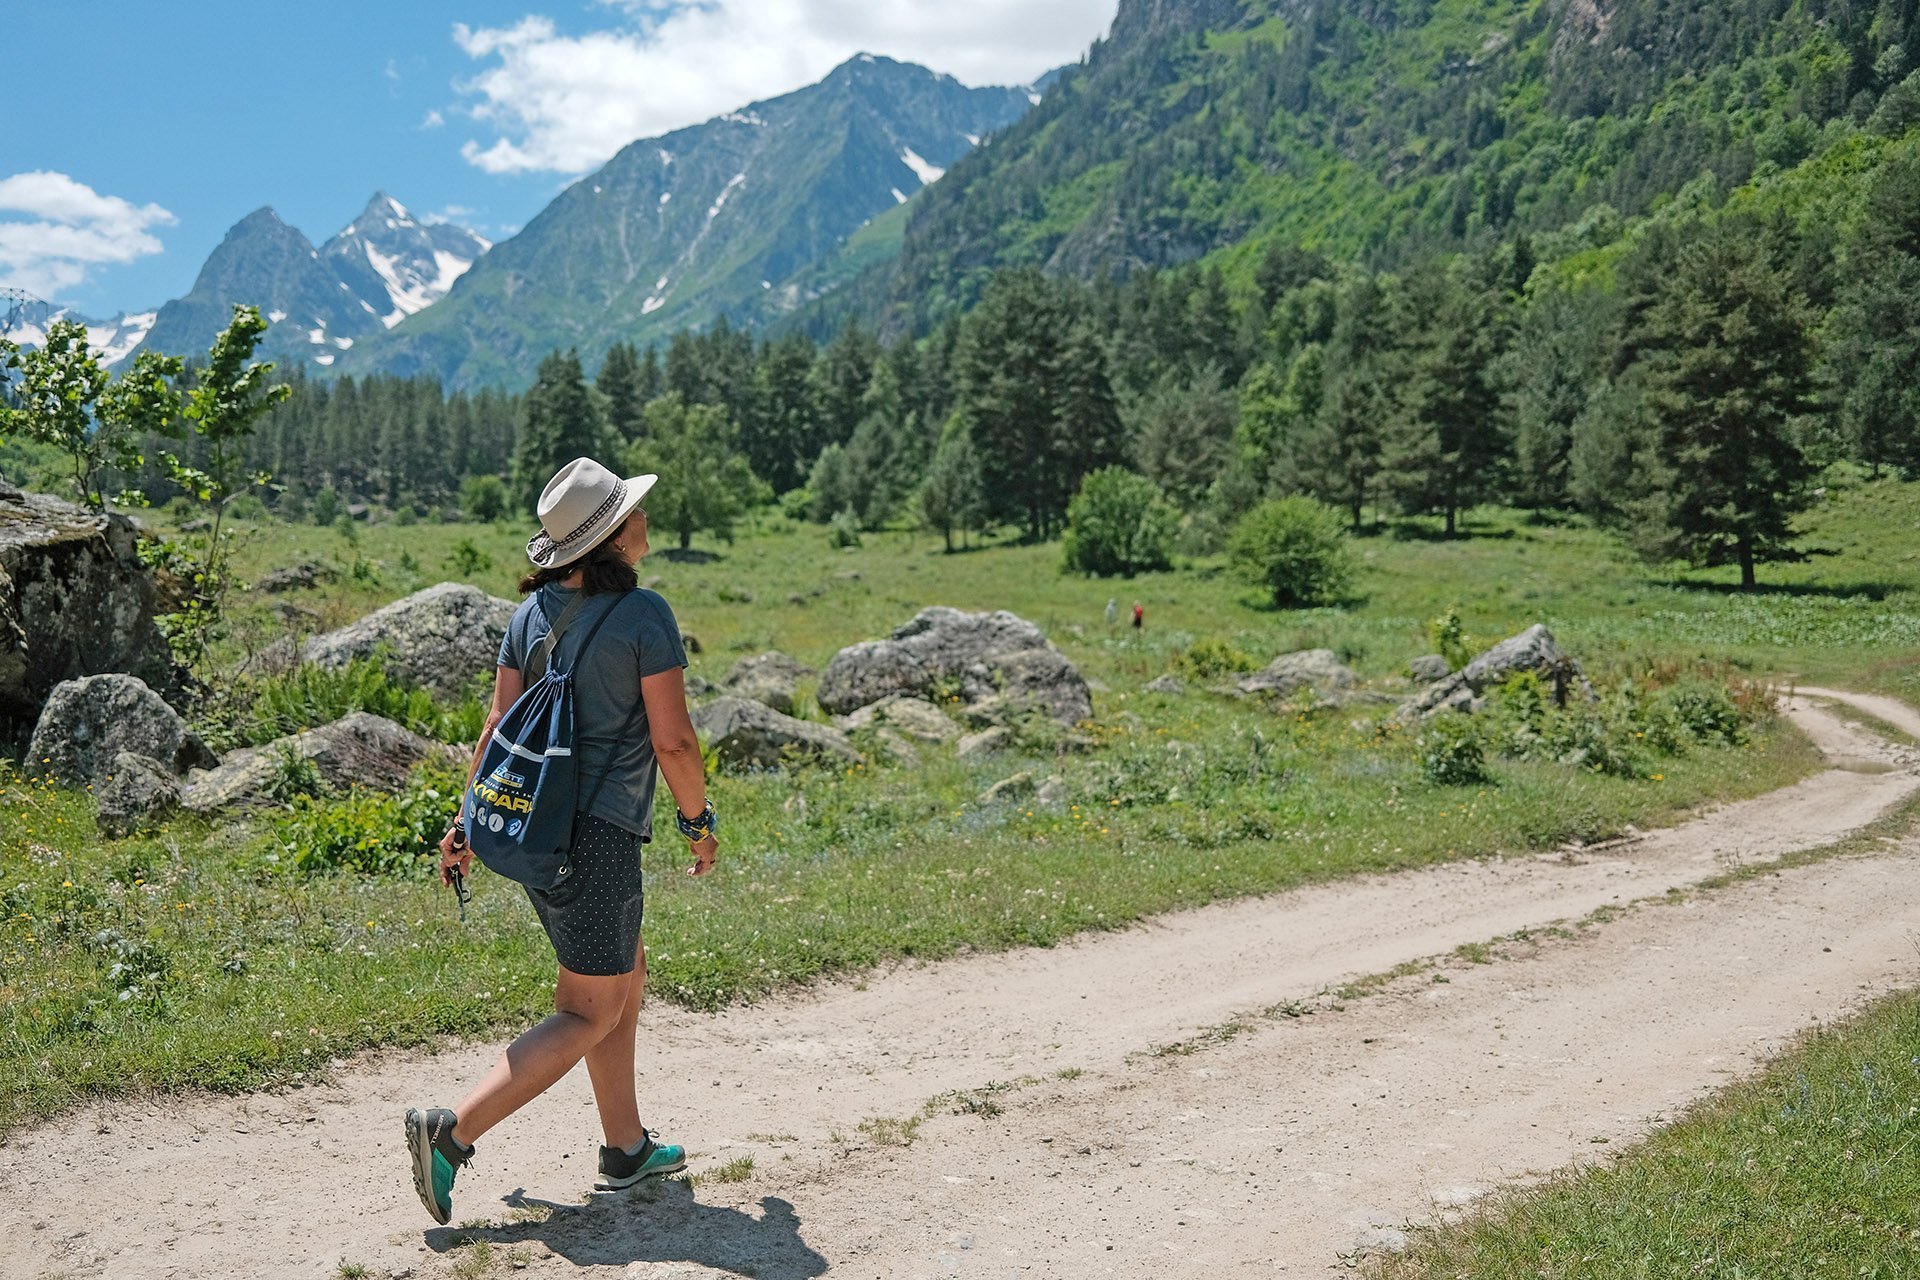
[526,814,645,977]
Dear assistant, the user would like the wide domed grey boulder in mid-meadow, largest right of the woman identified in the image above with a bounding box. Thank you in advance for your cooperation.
[816,606,1092,723]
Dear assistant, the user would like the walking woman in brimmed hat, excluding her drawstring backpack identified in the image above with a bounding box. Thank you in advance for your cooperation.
[407,459,718,1222]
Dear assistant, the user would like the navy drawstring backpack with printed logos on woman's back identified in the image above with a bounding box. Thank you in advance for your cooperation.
[461,595,637,889]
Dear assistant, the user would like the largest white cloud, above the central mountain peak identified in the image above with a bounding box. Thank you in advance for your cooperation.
[453,0,1116,173]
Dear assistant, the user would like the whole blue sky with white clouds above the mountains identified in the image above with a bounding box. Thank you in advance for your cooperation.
[0,0,1116,317]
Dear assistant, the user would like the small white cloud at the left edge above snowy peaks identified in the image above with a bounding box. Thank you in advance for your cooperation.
[0,171,177,299]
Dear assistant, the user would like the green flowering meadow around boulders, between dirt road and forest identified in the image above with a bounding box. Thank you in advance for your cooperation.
[0,466,1920,1132]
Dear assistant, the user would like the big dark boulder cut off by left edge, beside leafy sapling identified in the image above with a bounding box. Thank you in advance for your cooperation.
[0,482,177,718]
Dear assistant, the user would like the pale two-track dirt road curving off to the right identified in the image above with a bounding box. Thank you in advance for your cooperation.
[0,691,1920,1280]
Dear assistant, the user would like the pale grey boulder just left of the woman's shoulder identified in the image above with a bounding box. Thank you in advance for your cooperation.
[300,581,516,697]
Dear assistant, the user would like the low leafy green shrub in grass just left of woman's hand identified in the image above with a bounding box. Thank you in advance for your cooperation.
[276,766,465,879]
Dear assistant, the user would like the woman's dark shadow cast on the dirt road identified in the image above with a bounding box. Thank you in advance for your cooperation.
[426,1178,828,1280]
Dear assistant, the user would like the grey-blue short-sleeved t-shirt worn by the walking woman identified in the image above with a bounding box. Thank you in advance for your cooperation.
[499,585,687,839]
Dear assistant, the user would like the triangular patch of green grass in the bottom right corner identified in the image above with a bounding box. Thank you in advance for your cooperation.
[1365,992,1920,1280]
